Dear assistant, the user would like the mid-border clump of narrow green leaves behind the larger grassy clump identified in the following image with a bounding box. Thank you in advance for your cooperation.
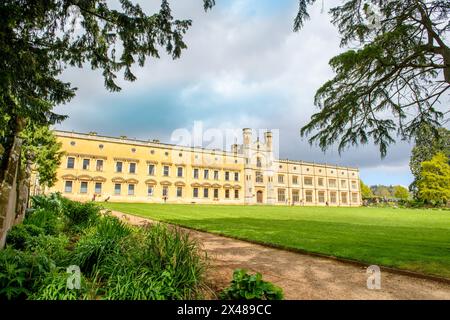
[73,216,131,275]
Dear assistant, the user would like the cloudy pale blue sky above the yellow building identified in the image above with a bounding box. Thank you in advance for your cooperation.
[53,0,418,186]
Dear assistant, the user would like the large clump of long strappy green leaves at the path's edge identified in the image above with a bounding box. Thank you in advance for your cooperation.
[99,225,205,300]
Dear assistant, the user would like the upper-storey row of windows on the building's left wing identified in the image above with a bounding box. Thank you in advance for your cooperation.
[67,157,239,181]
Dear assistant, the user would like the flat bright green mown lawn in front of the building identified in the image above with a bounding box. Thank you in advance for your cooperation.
[105,203,450,278]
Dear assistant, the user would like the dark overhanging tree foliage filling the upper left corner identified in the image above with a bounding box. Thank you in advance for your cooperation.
[0,0,214,181]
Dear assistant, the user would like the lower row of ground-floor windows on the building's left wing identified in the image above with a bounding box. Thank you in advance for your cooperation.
[64,180,239,199]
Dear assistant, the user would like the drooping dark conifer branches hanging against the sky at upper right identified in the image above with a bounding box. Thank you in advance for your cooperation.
[294,0,450,156]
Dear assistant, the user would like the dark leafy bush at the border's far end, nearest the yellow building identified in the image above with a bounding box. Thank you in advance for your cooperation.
[62,199,100,231]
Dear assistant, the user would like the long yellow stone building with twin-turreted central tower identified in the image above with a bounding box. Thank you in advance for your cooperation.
[46,129,361,206]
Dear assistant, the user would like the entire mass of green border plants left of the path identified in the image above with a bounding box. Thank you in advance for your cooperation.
[0,195,205,300]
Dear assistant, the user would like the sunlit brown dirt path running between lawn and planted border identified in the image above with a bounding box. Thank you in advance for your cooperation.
[113,211,450,300]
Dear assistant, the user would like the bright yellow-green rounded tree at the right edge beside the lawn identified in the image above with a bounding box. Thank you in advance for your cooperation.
[417,152,450,204]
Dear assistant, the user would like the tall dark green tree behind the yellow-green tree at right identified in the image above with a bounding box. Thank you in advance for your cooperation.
[409,125,450,198]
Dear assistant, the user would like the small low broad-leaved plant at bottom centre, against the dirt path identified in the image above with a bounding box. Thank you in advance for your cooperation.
[220,269,283,300]
